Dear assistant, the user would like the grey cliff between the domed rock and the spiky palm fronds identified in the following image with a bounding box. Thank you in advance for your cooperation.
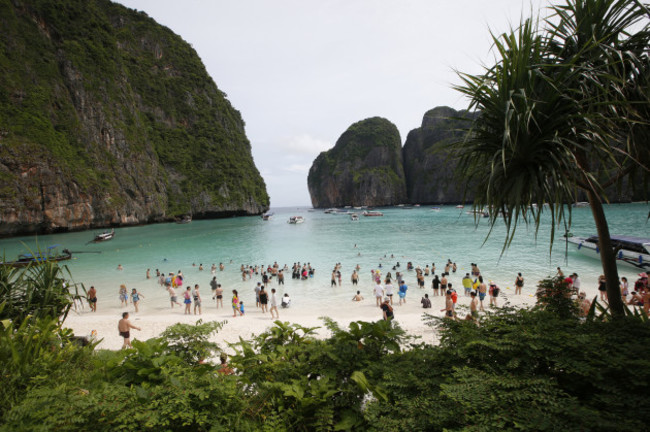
[402,107,471,204]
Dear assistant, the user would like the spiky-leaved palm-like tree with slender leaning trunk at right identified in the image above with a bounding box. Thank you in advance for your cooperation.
[457,0,650,316]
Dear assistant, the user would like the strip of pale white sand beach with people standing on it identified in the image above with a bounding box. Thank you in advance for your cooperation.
[65,274,576,349]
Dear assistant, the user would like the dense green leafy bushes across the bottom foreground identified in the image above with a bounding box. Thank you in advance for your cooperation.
[0,264,650,432]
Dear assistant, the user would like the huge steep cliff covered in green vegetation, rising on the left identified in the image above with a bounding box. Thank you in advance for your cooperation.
[0,0,269,235]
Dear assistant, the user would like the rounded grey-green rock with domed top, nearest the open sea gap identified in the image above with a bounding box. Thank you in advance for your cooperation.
[307,117,406,208]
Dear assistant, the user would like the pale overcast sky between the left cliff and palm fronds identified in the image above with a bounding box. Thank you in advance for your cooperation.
[118,0,557,207]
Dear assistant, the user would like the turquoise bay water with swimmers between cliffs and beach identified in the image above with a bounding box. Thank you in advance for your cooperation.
[0,204,650,308]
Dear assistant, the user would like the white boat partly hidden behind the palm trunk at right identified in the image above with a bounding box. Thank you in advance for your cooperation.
[567,236,650,270]
